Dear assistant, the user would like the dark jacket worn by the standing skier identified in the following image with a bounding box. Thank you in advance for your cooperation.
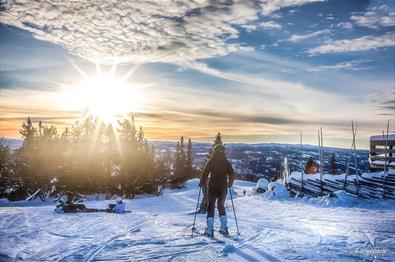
[199,157,234,187]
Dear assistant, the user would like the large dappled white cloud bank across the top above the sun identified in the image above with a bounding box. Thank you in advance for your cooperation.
[0,0,321,63]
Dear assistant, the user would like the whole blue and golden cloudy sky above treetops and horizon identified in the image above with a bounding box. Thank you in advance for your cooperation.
[0,0,395,148]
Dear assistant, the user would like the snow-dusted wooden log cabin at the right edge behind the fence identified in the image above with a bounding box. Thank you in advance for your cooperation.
[369,134,395,172]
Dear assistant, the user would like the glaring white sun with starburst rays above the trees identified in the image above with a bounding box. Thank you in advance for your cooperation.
[54,62,145,124]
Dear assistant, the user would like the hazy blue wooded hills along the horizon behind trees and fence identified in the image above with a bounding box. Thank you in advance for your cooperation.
[1,138,369,181]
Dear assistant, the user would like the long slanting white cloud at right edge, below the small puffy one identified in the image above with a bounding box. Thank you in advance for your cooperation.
[308,33,395,55]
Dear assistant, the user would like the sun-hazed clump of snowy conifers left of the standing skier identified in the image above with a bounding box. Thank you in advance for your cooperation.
[0,116,207,200]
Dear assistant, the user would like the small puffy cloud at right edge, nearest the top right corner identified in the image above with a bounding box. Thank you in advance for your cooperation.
[350,11,395,28]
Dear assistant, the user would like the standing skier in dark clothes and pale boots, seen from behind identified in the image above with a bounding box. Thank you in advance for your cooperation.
[199,145,234,237]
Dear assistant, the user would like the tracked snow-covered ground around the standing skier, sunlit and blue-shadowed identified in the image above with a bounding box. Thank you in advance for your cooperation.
[0,180,395,262]
